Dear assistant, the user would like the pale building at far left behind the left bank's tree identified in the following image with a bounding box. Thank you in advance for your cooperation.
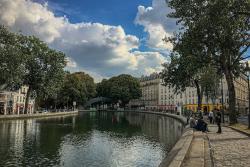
[0,86,35,115]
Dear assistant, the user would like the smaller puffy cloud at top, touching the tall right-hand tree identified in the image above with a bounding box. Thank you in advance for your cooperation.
[135,0,176,50]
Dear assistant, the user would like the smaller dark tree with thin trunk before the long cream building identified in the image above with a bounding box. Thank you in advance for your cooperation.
[161,53,210,109]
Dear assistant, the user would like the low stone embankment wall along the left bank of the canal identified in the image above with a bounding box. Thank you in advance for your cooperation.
[0,111,78,120]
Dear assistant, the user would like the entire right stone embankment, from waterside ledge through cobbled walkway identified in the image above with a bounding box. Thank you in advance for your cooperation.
[163,125,250,167]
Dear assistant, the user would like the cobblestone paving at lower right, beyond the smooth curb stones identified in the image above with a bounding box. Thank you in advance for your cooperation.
[207,125,250,167]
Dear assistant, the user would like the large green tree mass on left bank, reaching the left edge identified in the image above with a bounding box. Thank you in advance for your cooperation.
[0,26,66,113]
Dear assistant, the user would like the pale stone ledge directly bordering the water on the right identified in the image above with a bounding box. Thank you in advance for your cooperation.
[159,128,193,167]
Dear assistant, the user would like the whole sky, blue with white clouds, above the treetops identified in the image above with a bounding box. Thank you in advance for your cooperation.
[0,0,176,82]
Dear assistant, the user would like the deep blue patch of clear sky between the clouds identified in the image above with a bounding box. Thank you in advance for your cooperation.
[41,0,152,51]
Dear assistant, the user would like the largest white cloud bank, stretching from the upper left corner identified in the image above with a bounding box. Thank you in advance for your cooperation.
[0,0,168,80]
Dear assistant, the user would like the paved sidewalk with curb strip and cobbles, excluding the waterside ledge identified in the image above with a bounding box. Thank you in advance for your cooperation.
[181,125,250,167]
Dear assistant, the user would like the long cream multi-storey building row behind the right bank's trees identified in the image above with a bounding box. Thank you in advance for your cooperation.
[140,73,248,114]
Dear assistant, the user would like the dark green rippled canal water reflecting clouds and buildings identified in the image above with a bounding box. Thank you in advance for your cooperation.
[0,112,183,167]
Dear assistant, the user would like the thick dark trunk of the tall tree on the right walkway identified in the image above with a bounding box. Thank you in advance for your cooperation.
[225,68,237,124]
